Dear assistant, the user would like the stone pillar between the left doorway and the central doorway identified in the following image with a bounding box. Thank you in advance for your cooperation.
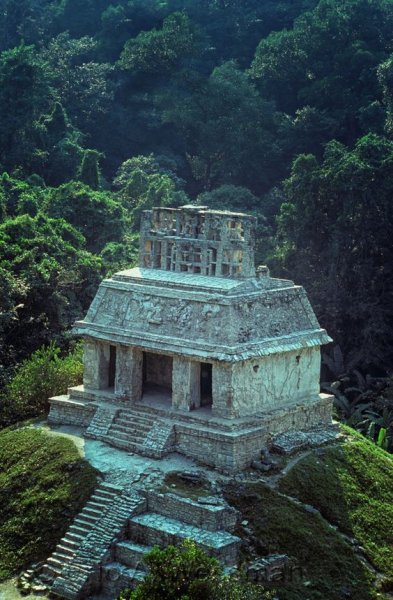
[115,346,143,403]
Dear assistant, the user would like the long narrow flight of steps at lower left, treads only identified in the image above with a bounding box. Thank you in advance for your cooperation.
[41,483,121,585]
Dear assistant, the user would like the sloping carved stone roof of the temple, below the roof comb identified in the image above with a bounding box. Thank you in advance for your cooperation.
[74,269,331,362]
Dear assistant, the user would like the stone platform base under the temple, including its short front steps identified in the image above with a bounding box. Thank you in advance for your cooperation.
[49,386,333,473]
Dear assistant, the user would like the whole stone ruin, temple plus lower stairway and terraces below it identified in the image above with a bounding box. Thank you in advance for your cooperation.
[29,206,336,600]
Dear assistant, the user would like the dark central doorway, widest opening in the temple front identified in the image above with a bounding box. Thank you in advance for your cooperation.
[142,352,173,398]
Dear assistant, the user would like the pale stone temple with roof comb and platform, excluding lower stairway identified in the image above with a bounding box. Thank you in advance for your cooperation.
[49,206,332,472]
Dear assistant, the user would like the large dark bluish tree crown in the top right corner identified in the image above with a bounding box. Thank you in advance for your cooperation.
[251,0,393,142]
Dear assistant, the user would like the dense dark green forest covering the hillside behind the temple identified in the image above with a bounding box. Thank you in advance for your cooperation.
[0,0,393,445]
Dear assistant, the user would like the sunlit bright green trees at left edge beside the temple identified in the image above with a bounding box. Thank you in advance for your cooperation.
[0,207,102,365]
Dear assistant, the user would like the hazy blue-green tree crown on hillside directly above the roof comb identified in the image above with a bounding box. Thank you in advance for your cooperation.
[159,61,280,190]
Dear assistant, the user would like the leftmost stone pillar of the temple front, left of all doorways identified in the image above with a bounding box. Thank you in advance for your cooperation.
[83,339,110,390]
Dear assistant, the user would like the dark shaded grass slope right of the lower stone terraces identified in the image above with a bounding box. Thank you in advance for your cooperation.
[226,483,378,600]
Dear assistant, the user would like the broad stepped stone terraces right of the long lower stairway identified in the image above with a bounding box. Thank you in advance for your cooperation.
[101,491,240,598]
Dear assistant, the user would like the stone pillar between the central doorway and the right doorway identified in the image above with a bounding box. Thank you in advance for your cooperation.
[172,356,201,411]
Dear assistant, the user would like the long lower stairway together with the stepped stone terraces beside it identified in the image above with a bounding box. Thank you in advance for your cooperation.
[35,483,240,600]
